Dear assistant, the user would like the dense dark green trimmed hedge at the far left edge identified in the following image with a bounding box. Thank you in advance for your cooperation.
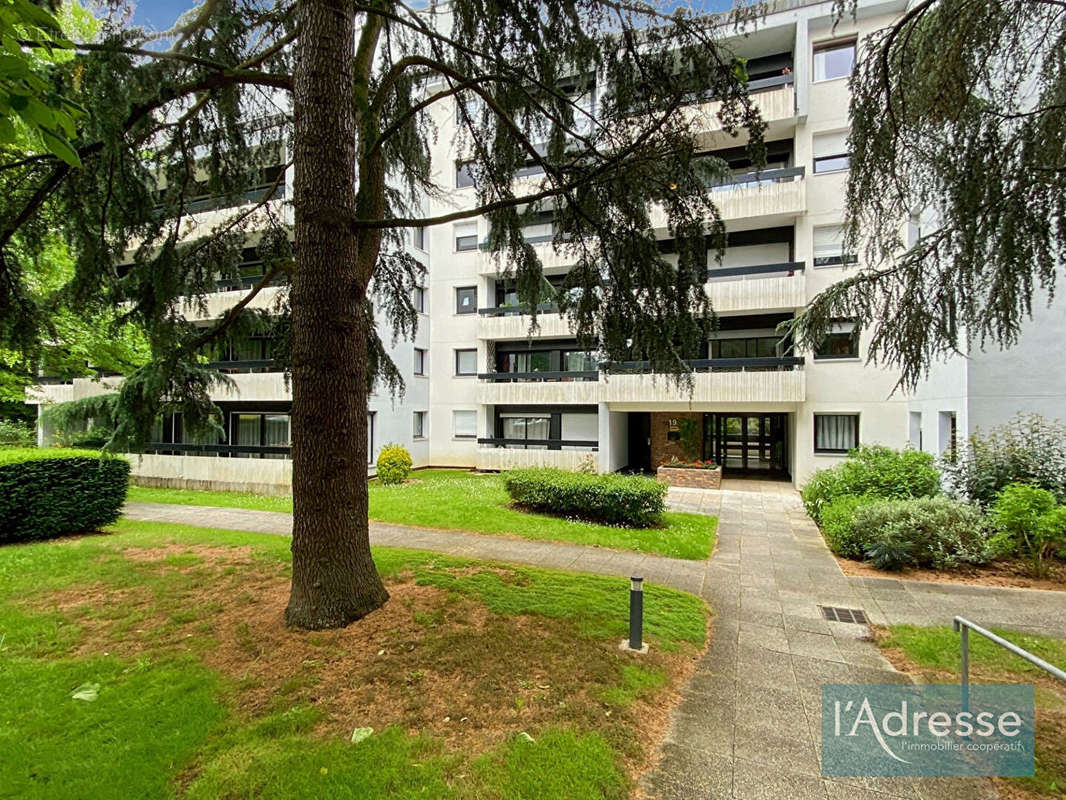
[0,449,130,542]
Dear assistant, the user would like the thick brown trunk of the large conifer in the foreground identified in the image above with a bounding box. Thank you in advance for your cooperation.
[285,0,388,629]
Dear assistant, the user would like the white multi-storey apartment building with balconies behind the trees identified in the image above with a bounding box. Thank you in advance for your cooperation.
[25,0,1066,491]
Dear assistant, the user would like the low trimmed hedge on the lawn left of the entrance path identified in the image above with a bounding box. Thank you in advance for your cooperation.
[503,469,666,528]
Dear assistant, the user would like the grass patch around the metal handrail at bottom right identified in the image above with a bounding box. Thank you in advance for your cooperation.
[877,625,1066,800]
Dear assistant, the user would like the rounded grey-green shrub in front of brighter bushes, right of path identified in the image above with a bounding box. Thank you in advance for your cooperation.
[852,497,989,570]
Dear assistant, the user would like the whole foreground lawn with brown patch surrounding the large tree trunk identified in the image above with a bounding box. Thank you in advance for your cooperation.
[0,522,707,800]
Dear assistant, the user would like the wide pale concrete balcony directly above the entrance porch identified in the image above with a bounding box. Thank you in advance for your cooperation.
[600,357,807,405]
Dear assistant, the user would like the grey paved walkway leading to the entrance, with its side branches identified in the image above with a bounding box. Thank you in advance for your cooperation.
[126,482,1066,800]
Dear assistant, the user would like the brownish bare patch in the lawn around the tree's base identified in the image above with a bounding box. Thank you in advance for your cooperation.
[29,545,698,775]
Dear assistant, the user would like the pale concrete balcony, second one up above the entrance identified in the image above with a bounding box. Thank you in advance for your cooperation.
[707,261,806,314]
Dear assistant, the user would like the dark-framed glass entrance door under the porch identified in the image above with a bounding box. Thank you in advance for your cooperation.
[704,414,788,475]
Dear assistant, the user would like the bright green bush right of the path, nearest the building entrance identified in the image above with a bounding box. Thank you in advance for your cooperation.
[802,445,940,522]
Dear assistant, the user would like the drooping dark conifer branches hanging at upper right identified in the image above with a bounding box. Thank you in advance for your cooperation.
[795,0,1066,387]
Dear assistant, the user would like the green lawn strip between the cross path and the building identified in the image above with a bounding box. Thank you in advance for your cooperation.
[129,469,717,560]
